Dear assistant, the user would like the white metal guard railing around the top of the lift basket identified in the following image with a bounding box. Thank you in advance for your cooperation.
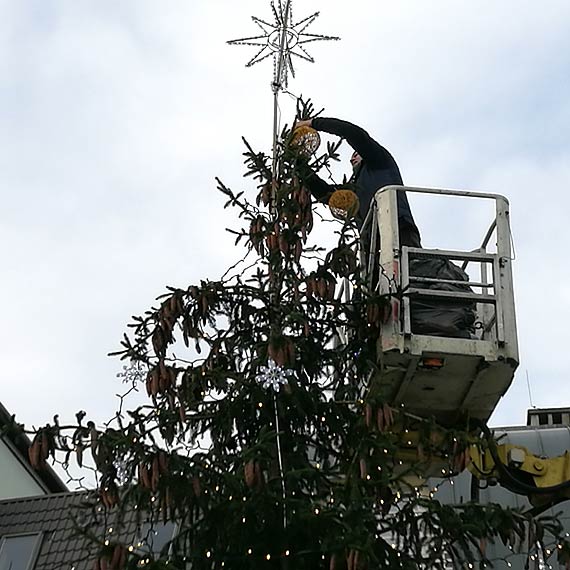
[368,186,516,347]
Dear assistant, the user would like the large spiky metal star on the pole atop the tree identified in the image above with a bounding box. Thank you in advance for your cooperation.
[228,0,340,91]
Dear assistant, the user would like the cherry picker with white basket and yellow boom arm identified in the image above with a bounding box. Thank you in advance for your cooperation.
[363,186,570,509]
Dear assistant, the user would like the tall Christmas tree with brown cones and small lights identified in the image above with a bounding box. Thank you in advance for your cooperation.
[21,2,568,570]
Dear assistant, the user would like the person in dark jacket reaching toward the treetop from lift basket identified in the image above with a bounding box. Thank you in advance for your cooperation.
[295,117,421,247]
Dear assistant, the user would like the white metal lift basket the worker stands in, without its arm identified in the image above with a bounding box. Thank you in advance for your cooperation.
[365,186,519,425]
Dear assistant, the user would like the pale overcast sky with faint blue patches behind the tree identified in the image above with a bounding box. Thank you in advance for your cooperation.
[0,0,570,432]
